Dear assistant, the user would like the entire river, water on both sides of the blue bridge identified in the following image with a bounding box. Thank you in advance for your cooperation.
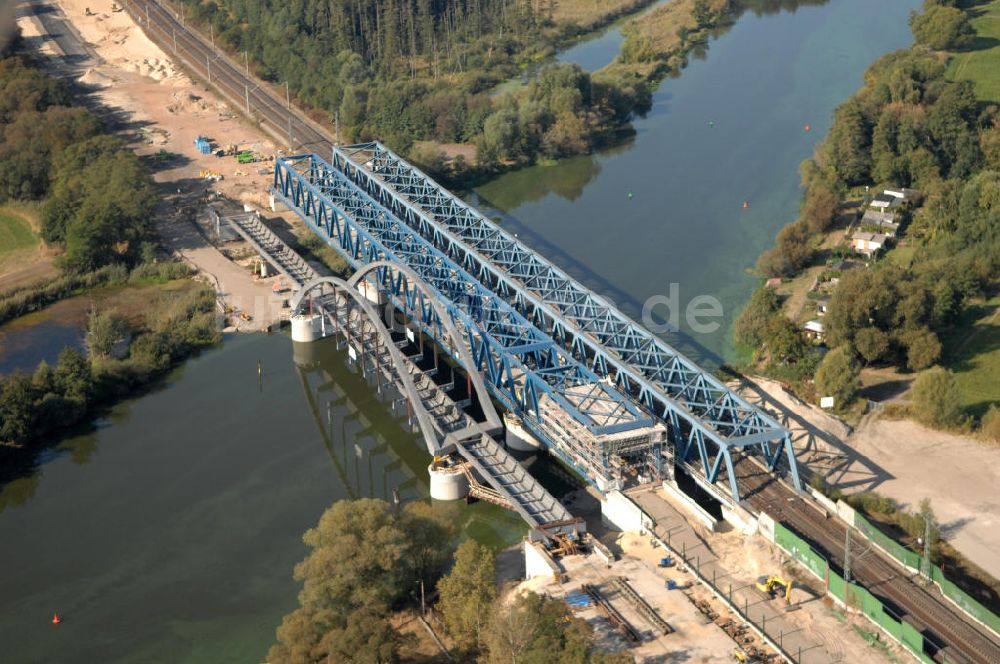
[0,0,919,664]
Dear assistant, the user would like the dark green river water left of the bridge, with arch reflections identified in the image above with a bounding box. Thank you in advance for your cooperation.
[0,335,524,664]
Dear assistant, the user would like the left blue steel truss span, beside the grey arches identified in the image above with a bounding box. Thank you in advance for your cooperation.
[274,155,651,444]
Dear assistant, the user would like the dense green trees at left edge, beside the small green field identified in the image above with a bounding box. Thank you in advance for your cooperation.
[0,55,156,272]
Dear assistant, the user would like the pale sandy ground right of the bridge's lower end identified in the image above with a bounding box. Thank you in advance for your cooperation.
[744,379,1000,578]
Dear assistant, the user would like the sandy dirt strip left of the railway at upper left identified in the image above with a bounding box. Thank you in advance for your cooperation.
[18,0,292,330]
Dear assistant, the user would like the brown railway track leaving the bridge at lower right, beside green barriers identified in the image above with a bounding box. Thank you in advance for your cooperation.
[735,457,1000,664]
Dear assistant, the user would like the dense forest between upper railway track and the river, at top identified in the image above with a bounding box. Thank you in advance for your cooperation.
[178,0,664,170]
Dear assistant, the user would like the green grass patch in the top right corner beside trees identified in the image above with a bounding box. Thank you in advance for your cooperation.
[948,0,1000,103]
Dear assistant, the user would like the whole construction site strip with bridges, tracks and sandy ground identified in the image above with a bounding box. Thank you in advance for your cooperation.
[17,0,1000,664]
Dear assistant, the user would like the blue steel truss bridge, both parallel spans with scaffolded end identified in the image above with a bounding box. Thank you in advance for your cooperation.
[273,143,800,502]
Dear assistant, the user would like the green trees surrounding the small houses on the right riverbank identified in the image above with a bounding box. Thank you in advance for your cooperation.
[734,0,1000,430]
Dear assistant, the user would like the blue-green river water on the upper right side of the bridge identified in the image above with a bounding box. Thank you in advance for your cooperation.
[472,0,920,365]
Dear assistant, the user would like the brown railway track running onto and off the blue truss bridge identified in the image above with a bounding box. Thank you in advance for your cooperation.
[115,7,1000,664]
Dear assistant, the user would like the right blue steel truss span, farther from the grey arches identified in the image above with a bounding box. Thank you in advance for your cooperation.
[334,143,800,500]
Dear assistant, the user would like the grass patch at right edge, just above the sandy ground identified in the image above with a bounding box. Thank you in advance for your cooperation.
[941,294,1000,417]
